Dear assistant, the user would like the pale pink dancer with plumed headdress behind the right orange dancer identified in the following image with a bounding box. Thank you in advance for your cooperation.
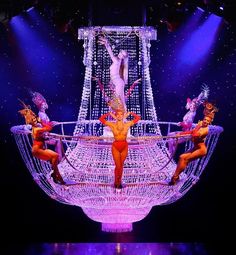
[168,85,209,154]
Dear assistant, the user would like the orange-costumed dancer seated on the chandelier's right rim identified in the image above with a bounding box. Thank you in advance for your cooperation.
[169,102,218,185]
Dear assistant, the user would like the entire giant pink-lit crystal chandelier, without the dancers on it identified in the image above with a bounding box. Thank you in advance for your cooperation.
[11,27,223,232]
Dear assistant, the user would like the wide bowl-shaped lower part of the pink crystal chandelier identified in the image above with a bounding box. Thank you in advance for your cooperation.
[11,120,223,231]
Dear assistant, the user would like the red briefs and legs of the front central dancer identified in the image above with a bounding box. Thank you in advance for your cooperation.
[112,141,128,188]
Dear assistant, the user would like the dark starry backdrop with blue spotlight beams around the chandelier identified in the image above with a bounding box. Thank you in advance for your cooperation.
[0,1,236,254]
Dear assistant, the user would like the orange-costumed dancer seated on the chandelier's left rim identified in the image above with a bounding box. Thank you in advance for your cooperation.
[19,104,65,184]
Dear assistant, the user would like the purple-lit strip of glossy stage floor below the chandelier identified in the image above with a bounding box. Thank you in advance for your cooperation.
[26,242,212,255]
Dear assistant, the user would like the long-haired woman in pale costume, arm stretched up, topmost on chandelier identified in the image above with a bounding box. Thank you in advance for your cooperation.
[98,37,128,110]
